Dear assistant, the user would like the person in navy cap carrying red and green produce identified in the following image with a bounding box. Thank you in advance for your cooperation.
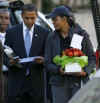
[45,6,96,103]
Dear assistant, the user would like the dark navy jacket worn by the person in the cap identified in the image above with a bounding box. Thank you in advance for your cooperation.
[45,25,96,85]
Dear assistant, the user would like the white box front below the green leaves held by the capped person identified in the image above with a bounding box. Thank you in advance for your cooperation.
[65,63,82,72]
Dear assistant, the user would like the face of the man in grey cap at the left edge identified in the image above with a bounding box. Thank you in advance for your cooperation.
[0,12,10,31]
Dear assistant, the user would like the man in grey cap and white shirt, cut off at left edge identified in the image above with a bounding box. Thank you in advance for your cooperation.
[0,7,10,101]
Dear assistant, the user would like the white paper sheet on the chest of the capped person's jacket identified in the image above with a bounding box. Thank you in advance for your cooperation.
[70,34,83,50]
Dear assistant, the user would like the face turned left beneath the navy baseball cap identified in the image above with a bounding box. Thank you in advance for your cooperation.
[52,16,66,30]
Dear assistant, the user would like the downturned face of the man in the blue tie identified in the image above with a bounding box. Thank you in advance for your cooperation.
[22,11,37,29]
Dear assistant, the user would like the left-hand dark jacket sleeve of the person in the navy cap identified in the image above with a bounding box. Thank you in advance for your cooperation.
[45,33,60,73]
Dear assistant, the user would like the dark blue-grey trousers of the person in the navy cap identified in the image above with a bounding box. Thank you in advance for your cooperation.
[51,79,80,103]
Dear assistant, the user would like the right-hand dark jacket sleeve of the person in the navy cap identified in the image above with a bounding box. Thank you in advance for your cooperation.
[82,32,96,75]
